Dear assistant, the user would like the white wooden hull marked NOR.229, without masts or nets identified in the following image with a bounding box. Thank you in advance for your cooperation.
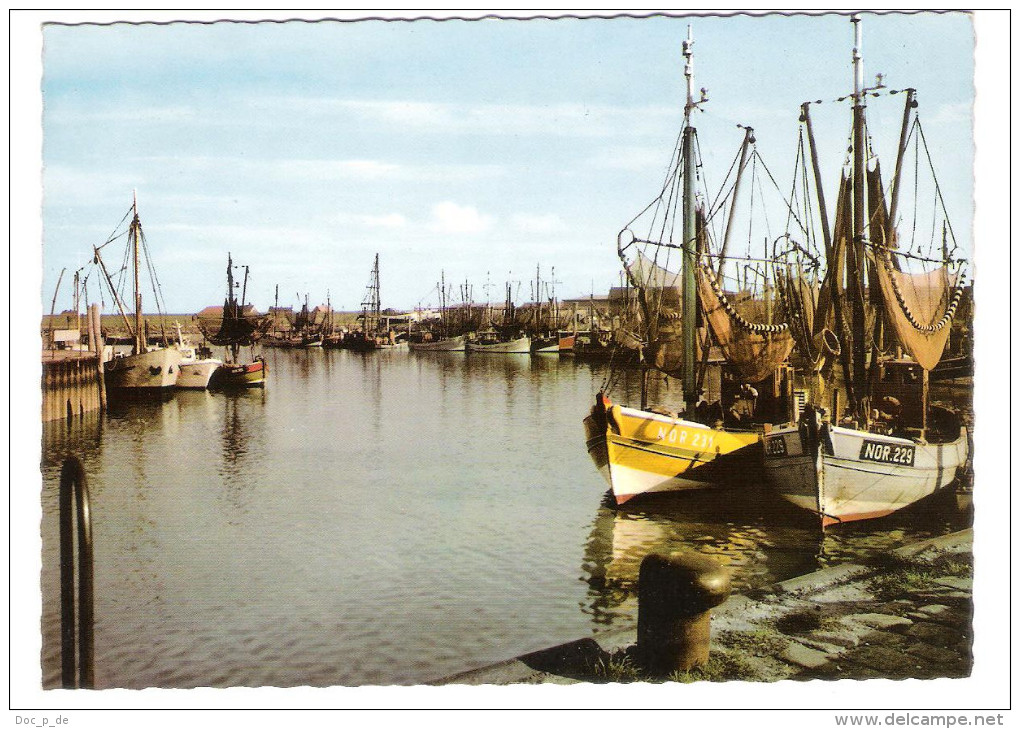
[764,426,968,528]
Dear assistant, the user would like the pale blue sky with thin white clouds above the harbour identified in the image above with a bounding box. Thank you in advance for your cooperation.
[33,13,974,313]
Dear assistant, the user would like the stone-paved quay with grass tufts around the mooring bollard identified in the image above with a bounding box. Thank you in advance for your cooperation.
[435,529,973,685]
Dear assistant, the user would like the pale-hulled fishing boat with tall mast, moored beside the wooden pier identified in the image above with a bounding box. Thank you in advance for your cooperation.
[93,196,181,395]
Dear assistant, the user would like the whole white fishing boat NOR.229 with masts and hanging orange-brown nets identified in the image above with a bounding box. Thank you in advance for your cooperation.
[764,16,968,528]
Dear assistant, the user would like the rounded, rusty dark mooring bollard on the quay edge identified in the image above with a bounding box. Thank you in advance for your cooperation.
[638,552,729,675]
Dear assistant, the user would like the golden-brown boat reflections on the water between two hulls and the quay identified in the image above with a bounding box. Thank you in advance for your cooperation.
[581,485,972,626]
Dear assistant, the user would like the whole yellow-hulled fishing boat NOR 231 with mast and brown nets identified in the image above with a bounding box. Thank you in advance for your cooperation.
[584,30,793,505]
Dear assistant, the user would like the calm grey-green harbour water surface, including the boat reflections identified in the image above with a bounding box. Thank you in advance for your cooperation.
[42,350,969,688]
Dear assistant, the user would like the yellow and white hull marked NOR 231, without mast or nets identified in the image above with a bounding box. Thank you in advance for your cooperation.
[584,395,761,505]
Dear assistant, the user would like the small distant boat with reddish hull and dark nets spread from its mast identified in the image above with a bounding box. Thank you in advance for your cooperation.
[197,253,271,388]
